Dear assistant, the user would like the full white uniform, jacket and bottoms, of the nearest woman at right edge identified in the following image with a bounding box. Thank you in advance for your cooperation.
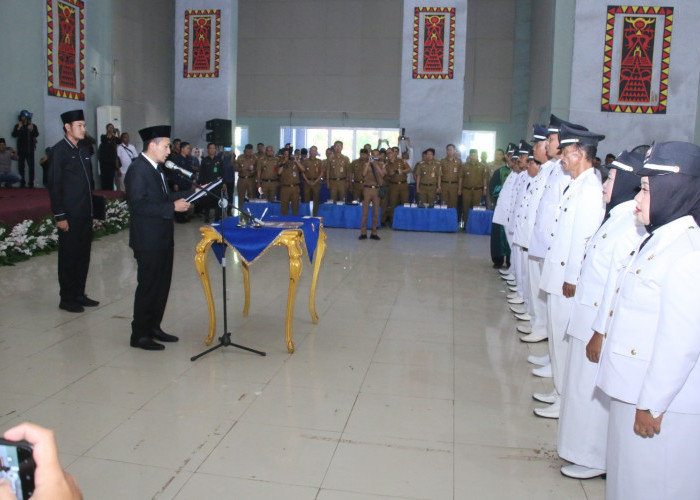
[596,216,700,500]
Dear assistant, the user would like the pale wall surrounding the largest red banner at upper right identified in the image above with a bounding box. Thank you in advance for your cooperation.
[569,0,700,157]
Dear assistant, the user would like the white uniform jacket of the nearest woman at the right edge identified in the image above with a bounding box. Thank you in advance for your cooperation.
[596,216,700,414]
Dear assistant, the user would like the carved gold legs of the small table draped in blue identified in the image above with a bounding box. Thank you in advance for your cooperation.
[194,226,326,353]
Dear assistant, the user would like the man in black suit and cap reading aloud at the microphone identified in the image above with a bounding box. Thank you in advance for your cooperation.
[124,125,193,351]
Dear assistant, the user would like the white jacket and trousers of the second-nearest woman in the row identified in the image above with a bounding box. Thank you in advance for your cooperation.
[557,200,647,470]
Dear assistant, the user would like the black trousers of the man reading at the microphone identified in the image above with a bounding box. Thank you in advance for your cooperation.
[131,247,174,338]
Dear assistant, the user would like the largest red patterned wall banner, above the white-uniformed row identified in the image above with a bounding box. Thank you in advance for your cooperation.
[601,5,673,114]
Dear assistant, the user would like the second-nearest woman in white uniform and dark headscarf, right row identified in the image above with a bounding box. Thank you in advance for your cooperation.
[557,151,647,479]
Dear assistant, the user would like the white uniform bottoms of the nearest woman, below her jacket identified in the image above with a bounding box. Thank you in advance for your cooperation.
[605,399,700,500]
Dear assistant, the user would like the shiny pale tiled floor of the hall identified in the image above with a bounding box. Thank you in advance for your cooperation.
[0,223,605,500]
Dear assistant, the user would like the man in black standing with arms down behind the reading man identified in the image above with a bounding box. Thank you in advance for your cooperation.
[48,109,99,313]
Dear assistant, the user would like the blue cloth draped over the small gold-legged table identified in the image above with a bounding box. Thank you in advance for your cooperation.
[211,215,321,263]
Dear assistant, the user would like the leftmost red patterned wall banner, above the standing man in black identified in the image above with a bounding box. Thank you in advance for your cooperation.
[46,0,85,101]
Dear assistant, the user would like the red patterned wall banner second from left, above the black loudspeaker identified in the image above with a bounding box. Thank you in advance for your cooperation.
[183,9,221,78]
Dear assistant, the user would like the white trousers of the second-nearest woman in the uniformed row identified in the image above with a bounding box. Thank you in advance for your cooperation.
[557,336,610,470]
